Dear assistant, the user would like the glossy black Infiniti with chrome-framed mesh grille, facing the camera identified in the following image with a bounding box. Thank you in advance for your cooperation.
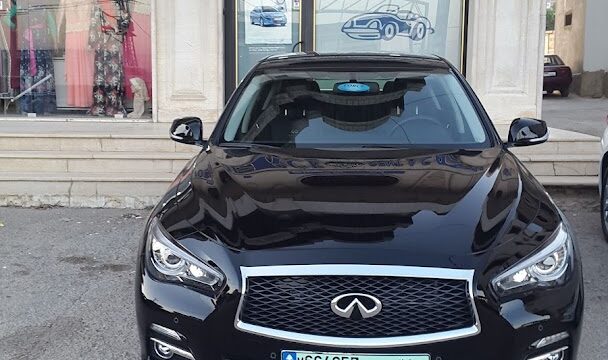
[136,54,583,360]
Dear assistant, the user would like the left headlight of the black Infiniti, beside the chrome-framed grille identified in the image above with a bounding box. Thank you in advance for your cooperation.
[147,218,224,292]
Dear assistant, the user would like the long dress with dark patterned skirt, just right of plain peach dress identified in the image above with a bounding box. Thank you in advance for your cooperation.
[89,0,128,116]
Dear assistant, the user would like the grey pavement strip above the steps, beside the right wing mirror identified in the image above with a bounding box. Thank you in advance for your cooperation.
[542,92,608,137]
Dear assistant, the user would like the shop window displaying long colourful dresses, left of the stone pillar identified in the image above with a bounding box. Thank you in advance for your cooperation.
[0,0,152,118]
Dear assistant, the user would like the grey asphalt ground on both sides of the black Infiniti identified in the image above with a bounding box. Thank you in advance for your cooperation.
[0,190,608,360]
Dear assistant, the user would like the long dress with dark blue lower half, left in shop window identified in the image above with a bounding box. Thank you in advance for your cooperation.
[17,0,57,115]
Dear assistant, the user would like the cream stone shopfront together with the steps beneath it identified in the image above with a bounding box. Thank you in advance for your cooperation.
[5,0,598,207]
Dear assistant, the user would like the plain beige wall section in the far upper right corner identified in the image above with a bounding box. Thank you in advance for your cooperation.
[583,0,608,71]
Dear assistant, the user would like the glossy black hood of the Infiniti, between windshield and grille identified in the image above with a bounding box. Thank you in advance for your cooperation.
[163,147,560,266]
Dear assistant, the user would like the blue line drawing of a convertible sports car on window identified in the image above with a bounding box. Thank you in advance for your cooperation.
[342,5,435,41]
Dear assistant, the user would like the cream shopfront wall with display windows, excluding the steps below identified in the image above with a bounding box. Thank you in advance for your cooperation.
[0,0,545,124]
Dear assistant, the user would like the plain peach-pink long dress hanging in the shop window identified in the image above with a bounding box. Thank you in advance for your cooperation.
[65,31,95,107]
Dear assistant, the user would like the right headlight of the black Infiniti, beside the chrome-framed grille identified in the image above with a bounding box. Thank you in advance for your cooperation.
[492,224,572,294]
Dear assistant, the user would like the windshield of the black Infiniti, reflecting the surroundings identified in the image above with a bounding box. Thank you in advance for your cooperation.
[221,69,488,148]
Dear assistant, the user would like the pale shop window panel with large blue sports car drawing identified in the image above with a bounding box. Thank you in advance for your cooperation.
[315,0,464,66]
